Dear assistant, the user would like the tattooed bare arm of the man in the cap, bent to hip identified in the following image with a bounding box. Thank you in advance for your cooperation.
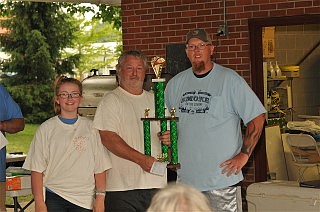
[220,113,265,176]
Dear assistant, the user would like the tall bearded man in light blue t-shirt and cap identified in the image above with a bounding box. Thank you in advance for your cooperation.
[165,29,266,211]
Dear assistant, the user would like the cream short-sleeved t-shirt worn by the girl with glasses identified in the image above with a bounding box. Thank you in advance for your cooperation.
[23,116,111,209]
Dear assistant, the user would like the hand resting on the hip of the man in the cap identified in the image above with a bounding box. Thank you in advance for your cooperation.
[220,152,249,177]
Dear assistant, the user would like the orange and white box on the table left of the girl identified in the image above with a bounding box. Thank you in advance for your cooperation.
[6,175,31,191]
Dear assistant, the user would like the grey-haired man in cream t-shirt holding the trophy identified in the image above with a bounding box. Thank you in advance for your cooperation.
[94,51,170,212]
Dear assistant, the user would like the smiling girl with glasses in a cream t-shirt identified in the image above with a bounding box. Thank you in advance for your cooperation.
[23,77,111,212]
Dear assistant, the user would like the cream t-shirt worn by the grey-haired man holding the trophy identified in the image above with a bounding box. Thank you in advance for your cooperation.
[93,87,167,191]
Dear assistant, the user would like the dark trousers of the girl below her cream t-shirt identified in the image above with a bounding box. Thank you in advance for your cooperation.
[46,191,92,212]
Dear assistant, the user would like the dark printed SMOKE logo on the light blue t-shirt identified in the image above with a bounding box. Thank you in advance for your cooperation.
[179,90,211,114]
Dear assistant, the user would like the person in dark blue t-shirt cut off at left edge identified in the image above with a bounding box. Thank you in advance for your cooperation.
[0,84,24,212]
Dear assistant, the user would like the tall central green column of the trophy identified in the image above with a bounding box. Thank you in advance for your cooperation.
[152,79,168,161]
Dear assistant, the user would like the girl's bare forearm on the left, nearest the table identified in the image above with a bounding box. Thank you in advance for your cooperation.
[31,171,47,212]
